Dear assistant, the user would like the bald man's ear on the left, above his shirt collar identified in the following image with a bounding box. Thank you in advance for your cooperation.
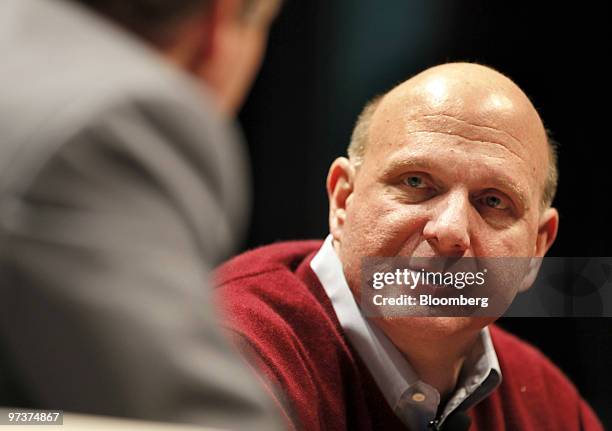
[327,157,355,241]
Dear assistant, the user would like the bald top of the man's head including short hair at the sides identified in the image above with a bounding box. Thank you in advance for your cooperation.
[348,63,557,208]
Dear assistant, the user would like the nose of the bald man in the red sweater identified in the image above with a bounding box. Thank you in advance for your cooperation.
[423,190,470,256]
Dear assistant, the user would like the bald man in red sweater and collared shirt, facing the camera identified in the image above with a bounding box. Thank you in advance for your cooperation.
[219,63,602,430]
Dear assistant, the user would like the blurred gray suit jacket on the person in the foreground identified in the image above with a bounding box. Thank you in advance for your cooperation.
[0,0,276,430]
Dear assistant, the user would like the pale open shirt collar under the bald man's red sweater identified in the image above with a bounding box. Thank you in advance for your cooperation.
[310,235,502,430]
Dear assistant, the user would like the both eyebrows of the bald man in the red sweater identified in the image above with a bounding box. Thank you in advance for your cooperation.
[382,156,529,210]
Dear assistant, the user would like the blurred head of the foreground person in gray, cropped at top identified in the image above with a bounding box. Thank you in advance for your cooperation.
[75,0,281,115]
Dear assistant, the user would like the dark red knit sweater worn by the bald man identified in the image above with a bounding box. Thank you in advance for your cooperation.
[217,241,603,431]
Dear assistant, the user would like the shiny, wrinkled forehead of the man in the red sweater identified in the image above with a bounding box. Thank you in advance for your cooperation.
[366,66,548,179]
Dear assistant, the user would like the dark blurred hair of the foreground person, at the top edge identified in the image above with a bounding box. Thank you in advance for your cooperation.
[73,0,212,43]
